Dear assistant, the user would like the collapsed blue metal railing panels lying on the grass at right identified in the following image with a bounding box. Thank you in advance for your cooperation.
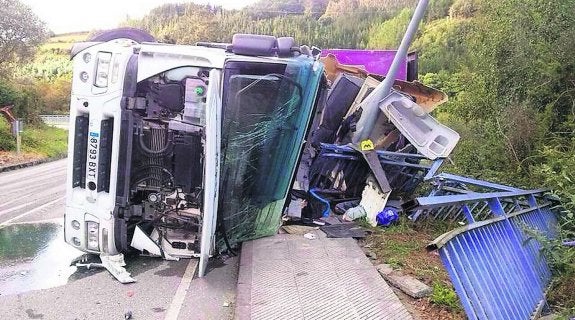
[418,182,557,320]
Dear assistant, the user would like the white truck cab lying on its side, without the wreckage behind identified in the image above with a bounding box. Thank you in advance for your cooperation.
[65,30,323,276]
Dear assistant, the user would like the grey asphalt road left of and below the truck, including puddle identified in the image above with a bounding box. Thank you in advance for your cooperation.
[0,159,239,320]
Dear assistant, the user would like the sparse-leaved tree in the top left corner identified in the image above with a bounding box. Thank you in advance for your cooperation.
[0,0,47,76]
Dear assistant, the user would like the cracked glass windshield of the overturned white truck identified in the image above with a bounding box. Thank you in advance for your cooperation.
[218,62,309,242]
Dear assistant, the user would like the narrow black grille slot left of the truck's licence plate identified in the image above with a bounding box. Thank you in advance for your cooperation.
[72,116,89,188]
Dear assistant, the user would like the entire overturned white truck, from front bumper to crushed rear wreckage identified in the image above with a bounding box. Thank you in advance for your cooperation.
[65,28,472,282]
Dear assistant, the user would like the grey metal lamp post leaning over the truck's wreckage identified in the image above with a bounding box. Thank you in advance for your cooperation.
[352,0,429,143]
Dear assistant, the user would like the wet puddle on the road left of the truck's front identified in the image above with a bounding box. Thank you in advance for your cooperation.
[0,223,82,295]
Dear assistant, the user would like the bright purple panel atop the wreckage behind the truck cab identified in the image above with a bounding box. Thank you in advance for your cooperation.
[321,49,407,80]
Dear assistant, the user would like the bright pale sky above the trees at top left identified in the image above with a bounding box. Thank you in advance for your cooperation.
[20,0,256,34]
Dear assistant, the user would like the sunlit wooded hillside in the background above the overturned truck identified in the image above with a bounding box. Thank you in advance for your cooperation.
[123,0,415,48]
